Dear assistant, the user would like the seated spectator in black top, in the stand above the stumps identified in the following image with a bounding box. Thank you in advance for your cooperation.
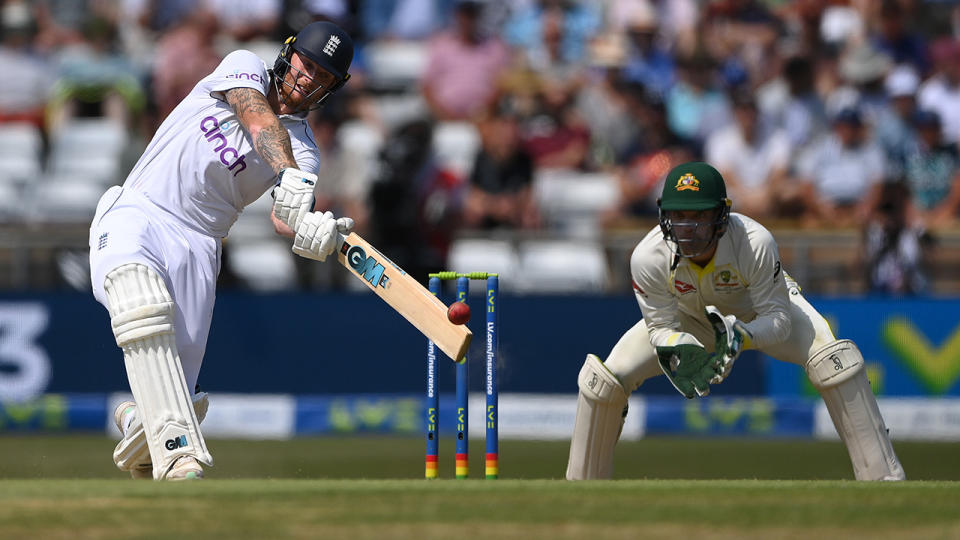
[463,109,539,229]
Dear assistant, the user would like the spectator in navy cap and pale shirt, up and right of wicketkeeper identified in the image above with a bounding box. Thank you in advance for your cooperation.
[796,109,886,227]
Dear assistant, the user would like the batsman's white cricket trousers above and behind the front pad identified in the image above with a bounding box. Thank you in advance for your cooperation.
[90,186,220,392]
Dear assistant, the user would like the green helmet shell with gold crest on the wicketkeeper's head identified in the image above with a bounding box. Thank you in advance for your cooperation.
[658,161,730,210]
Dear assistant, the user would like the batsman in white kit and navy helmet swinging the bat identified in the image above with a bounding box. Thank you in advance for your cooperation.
[90,22,353,480]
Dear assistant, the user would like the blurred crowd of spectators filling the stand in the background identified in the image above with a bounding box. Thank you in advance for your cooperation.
[0,0,960,292]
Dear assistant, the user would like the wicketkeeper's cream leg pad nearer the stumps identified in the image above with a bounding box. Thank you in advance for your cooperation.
[567,354,628,480]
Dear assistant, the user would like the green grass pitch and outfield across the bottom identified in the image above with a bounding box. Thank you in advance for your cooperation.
[0,435,960,540]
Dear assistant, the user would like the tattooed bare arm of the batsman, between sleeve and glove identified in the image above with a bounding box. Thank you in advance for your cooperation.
[224,88,297,173]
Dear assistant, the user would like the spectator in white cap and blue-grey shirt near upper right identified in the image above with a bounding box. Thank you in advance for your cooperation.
[873,64,920,177]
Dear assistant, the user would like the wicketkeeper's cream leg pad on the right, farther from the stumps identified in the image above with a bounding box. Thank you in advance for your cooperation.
[806,339,906,480]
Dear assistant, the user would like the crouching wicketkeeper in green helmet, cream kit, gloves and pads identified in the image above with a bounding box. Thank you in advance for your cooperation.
[566,162,905,480]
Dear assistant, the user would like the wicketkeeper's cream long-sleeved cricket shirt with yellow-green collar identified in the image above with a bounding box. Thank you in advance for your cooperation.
[630,213,790,348]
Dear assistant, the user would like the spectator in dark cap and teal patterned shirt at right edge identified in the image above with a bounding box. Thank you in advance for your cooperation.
[904,110,960,228]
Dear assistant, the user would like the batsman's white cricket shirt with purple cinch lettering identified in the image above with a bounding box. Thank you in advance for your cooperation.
[124,50,320,238]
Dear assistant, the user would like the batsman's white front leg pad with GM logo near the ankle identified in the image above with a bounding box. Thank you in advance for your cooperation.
[103,264,213,480]
